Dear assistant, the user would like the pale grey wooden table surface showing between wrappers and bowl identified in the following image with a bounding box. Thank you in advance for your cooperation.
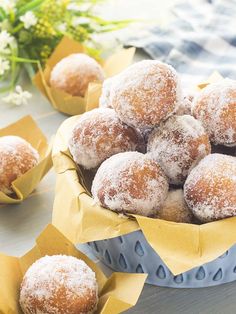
[0,1,236,314]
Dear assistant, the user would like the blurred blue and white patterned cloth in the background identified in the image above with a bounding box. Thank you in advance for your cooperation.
[128,0,236,84]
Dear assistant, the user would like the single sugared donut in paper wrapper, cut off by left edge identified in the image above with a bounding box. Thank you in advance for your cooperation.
[0,136,39,194]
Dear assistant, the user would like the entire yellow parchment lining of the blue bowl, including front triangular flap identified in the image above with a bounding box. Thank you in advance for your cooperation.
[53,73,236,275]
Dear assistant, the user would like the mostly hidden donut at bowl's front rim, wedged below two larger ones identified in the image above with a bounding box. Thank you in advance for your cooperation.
[157,189,194,223]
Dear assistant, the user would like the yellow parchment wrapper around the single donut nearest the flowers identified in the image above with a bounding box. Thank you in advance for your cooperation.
[33,37,135,115]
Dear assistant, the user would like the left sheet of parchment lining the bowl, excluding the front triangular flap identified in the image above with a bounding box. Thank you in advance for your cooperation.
[52,116,139,243]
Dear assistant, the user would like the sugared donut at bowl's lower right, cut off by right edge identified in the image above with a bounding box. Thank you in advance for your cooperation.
[184,154,236,222]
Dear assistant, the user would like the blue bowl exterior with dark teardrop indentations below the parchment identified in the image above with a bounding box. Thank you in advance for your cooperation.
[88,231,236,288]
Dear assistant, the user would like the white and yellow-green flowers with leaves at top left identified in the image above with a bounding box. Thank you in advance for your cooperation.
[0,0,129,105]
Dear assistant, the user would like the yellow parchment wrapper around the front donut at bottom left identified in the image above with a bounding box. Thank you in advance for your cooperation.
[0,225,147,314]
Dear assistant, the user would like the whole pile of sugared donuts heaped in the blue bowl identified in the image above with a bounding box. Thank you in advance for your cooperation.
[68,60,236,223]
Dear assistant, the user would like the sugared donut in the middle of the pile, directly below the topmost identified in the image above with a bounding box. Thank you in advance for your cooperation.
[147,115,211,185]
